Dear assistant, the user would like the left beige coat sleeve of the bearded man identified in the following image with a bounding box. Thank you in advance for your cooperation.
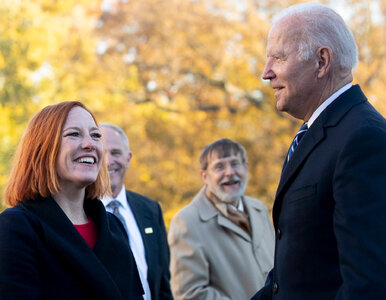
[168,214,231,300]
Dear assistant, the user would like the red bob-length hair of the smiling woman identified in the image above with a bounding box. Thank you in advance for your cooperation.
[4,101,110,206]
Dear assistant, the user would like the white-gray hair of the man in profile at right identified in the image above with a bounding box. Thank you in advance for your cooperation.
[273,3,358,70]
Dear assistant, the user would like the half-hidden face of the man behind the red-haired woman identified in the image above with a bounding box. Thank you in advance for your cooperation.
[101,127,131,197]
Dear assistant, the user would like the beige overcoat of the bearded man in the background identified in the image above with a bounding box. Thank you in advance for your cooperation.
[168,188,274,300]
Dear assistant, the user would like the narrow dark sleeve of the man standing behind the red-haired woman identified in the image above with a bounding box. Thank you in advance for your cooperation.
[157,203,173,300]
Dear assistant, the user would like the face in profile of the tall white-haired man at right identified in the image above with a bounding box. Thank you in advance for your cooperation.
[262,19,319,119]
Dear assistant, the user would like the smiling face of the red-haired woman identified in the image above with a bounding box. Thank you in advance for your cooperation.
[56,106,103,189]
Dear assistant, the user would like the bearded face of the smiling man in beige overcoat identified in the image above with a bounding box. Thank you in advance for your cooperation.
[201,152,248,203]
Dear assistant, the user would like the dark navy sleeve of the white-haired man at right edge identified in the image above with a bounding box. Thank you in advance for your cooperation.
[333,123,386,300]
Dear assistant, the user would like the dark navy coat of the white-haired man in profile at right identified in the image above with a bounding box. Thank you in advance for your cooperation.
[252,86,386,300]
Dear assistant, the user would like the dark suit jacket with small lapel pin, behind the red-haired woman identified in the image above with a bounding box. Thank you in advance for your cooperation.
[126,191,173,300]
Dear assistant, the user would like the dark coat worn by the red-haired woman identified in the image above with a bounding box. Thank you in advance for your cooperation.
[0,198,143,300]
